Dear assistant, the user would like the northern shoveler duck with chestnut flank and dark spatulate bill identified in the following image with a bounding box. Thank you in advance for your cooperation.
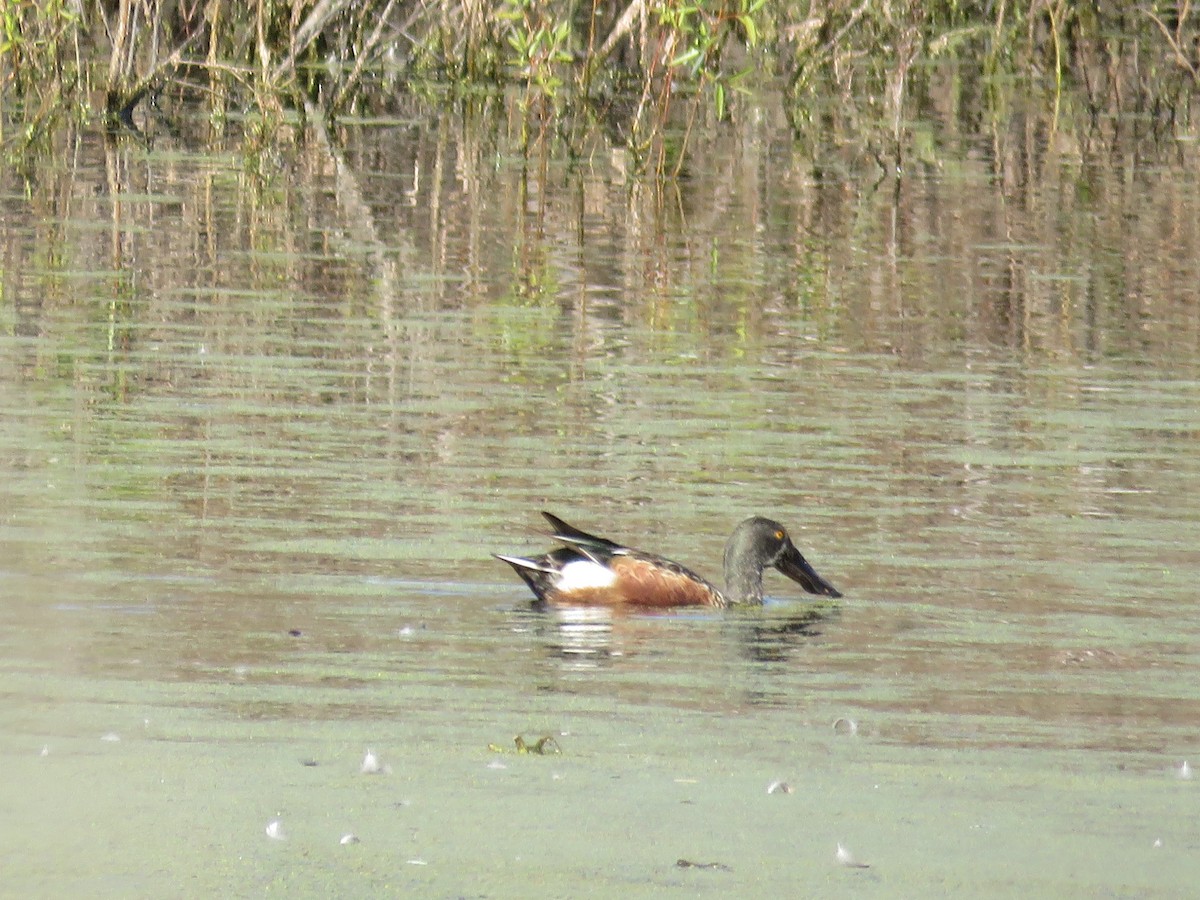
[494,512,841,607]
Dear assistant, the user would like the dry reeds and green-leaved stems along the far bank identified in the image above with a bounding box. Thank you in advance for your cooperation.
[0,0,1200,174]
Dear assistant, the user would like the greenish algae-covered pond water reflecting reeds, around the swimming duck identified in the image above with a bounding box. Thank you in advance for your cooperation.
[0,95,1200,898]
